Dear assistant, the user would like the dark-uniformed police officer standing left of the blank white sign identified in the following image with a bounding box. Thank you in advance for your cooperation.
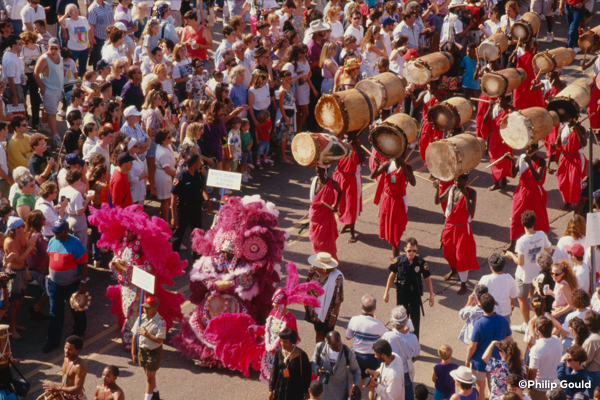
[171,154,211,252]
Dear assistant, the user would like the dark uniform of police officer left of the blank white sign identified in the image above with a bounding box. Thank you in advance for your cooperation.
[171,168,206,251]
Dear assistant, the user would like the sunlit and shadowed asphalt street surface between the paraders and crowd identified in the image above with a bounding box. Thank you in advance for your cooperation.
[16,5,600,400]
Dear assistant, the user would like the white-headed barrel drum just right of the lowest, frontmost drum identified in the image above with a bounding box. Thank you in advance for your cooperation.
[500,107,560,150]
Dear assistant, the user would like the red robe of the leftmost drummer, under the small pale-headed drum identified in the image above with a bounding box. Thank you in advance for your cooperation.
[308,179,339,261]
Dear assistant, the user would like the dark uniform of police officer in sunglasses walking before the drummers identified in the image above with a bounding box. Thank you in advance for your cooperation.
[388,254,431,337]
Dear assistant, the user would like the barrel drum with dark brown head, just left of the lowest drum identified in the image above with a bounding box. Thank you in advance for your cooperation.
[369,113,419,158]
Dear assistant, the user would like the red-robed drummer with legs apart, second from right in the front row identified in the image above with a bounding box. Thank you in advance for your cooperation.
[507,143,550,251]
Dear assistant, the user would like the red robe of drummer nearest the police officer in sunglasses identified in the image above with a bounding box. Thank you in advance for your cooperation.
[442,186,479,272]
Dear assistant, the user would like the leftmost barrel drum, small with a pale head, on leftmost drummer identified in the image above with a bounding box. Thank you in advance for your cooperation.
[292,132,352,167]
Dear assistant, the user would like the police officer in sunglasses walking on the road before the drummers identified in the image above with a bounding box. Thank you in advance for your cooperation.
[383,237,434,337]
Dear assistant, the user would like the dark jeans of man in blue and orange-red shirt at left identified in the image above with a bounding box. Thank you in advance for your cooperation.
[47,278,87,345]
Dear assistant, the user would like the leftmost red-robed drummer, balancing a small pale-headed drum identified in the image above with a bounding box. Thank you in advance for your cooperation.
[308,166,342,262]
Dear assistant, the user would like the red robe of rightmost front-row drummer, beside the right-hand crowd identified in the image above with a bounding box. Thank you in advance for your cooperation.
[556,126,587,204]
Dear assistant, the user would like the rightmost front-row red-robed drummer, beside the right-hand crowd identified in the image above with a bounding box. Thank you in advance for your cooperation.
[552,122,587,211]
